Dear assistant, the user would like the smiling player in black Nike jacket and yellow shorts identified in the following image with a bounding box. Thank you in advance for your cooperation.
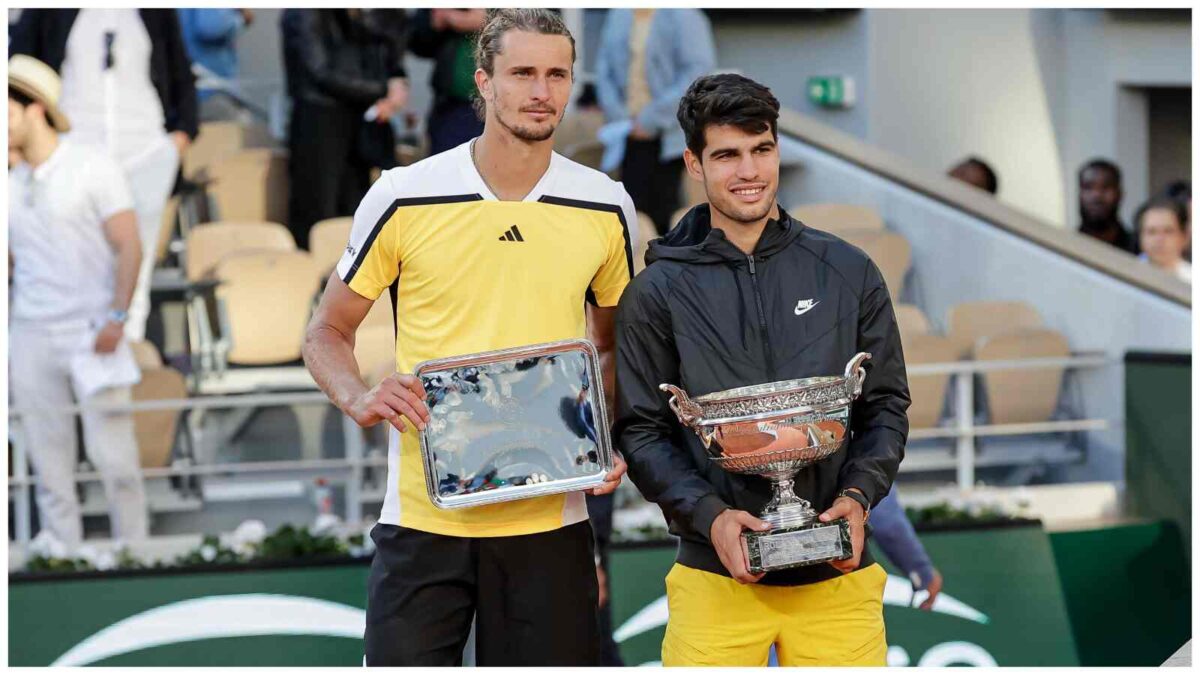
[614,74,910,665]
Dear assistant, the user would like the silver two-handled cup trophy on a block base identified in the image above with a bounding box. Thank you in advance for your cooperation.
[659,352,871,574]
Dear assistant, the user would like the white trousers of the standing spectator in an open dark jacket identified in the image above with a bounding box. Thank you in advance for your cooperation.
[125,136,179,341]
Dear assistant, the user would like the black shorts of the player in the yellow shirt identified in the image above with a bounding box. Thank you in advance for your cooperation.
[366,521,600,665]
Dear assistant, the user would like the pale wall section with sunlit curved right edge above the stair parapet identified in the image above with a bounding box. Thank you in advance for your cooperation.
[868,10,1064,225]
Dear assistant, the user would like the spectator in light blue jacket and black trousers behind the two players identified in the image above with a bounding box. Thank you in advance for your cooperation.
[595,7,716,233]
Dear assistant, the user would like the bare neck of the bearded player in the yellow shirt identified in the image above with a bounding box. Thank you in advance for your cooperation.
[475,123,554,202]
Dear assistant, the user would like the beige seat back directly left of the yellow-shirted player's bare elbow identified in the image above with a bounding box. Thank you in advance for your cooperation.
[214,251,319,365]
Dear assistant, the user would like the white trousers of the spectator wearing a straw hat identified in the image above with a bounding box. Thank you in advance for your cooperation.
[8,321,149,548]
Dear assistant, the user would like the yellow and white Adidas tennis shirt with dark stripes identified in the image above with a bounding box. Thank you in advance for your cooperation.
[337,143,637,537]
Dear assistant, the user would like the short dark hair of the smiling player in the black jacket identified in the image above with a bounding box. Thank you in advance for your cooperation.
[676,73,779,157]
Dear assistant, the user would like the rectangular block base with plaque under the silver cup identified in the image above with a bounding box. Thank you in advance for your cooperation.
[743,518,854,574]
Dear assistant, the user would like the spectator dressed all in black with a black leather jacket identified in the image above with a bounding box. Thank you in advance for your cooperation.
[280,8,408,249]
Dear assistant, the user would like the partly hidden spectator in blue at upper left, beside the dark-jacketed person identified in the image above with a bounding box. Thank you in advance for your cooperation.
[176,8,254,121]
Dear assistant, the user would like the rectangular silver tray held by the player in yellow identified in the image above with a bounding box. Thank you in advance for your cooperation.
[415,340,613,509]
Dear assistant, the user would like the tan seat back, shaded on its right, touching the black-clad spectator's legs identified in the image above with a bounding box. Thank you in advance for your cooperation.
[205,148,288,222]
